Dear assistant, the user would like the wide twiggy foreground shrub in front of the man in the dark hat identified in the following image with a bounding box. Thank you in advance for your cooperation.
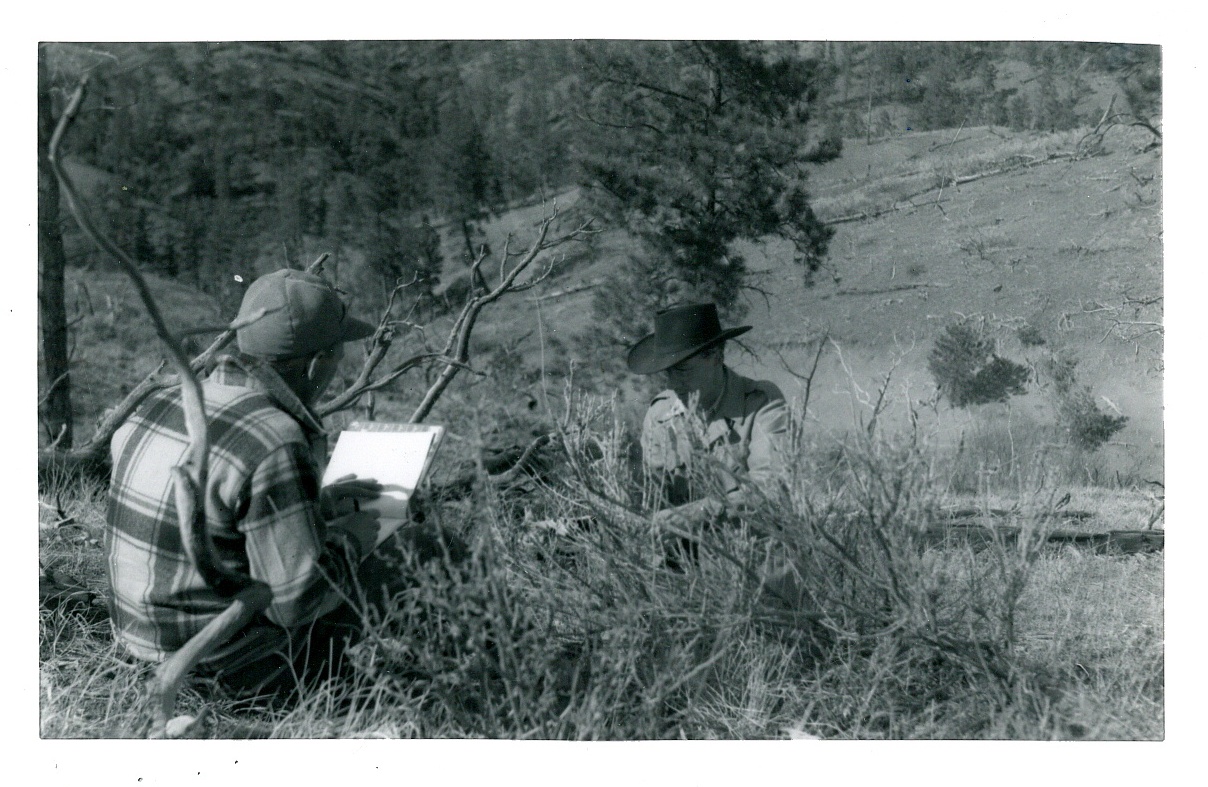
[340,401,1067,739]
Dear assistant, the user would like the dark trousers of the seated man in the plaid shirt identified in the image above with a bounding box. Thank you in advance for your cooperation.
[197,525,469,696]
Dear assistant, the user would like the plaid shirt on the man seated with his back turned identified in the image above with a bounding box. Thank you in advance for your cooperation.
[105,357,361,661]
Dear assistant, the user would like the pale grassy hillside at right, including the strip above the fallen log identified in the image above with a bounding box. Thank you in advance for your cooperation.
[750,129,1162,478]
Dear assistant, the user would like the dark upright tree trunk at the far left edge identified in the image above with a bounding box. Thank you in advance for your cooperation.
[37,48,72,449]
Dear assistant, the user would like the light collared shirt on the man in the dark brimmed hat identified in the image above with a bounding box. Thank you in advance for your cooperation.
[641,366,788,505]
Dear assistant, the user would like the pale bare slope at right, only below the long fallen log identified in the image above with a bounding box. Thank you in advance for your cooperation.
[750,125,1162,437]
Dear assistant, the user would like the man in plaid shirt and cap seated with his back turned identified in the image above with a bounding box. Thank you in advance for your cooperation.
[105,270,454,693]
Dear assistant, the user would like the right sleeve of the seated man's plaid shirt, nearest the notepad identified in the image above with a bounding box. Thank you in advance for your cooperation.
[239,444,361,629]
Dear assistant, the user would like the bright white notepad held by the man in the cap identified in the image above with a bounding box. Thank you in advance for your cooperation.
[323,421,445,545]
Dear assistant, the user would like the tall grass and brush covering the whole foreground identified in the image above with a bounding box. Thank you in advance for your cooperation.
[42,397,1162,740]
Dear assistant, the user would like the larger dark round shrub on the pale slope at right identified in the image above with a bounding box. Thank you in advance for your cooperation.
[928,324,1029,407]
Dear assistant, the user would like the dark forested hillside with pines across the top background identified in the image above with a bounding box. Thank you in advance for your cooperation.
[40,41,1161,454]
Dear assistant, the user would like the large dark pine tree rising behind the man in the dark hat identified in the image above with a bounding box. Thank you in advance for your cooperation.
[577,41,838,323]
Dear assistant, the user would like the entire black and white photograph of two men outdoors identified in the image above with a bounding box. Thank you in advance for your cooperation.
[23,4,1193,783]
